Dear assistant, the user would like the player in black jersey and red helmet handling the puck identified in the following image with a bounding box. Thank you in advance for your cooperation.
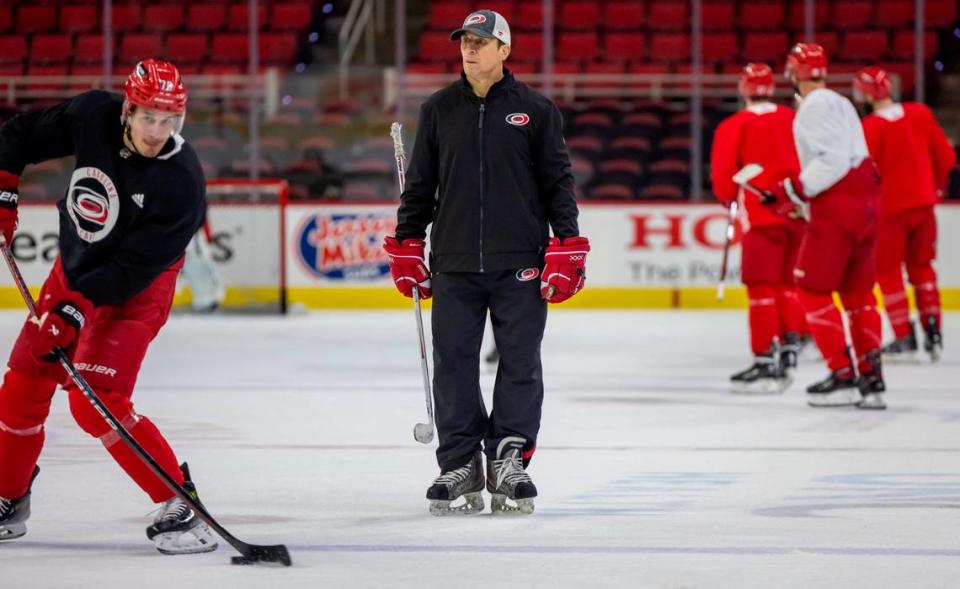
[0,60,217,554]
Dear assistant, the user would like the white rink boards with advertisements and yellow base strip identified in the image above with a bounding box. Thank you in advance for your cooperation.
[0,203,960,309]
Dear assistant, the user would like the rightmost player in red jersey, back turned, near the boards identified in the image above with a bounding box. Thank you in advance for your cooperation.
[853,67,956,361]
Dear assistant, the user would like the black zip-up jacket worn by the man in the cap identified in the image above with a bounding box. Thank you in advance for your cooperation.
[397,69,579,272]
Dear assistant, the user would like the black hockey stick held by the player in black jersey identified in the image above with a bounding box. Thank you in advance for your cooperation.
[0,241,292,566]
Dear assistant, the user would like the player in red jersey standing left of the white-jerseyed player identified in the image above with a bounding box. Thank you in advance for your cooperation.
[710,63,806,393]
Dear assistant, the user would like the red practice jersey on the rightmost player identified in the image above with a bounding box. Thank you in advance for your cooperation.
[863,102,956,215]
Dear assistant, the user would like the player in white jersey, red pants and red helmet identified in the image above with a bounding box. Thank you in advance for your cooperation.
[765,43,886,409]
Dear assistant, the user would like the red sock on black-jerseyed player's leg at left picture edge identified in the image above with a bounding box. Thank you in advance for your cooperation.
[0,370,57,499]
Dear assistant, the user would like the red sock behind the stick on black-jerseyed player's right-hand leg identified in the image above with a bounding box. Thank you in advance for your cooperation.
[101,417,183,503]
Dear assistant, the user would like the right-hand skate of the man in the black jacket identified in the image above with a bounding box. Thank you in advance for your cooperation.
[487,437,537,515]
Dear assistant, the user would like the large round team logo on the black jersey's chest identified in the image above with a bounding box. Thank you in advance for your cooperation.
[67,167,120,243]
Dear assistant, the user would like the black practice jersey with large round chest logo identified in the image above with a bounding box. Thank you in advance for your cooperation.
[0,90,206,306]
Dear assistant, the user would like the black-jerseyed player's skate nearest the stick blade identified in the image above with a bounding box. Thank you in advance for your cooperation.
[147,462,218,554]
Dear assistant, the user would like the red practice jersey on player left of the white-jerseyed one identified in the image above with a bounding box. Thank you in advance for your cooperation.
[710,102,800,226]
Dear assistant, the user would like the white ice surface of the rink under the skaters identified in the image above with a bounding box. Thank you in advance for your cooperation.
[0,312,960,589]
